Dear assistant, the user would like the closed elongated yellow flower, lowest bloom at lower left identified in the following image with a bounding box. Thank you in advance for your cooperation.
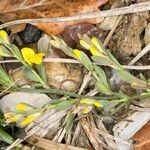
[20,112,41,126]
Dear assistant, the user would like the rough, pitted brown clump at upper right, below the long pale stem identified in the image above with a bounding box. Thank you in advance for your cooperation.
[109,12,149,57]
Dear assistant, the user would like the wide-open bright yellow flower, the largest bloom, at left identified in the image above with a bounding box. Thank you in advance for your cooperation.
[21,48,45,65]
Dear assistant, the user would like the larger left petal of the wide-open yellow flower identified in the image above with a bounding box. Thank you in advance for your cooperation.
[21,48,35,65]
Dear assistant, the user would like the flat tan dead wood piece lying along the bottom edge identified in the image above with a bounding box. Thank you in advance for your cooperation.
[26,135,86,150]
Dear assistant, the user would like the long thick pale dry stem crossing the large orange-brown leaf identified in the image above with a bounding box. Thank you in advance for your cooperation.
[0,2,150,29]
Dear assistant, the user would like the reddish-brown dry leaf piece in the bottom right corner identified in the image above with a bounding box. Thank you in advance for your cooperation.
[132,123,150,150]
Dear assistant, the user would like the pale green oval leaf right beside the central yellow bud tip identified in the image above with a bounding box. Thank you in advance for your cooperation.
[80,52,93,72]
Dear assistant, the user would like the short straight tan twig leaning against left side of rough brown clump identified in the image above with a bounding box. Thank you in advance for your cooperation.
[104,15,123,47]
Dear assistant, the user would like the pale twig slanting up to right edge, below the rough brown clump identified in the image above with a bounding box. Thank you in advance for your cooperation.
[128,43,150,67]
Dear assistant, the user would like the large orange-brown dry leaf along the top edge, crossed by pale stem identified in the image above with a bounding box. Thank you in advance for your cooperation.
[0,0,108,35]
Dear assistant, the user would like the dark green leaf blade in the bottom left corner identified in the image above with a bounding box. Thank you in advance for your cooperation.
[0,128,14,144]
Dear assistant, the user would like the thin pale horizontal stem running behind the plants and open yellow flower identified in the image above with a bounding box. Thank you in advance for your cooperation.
[0,58,150,70]
